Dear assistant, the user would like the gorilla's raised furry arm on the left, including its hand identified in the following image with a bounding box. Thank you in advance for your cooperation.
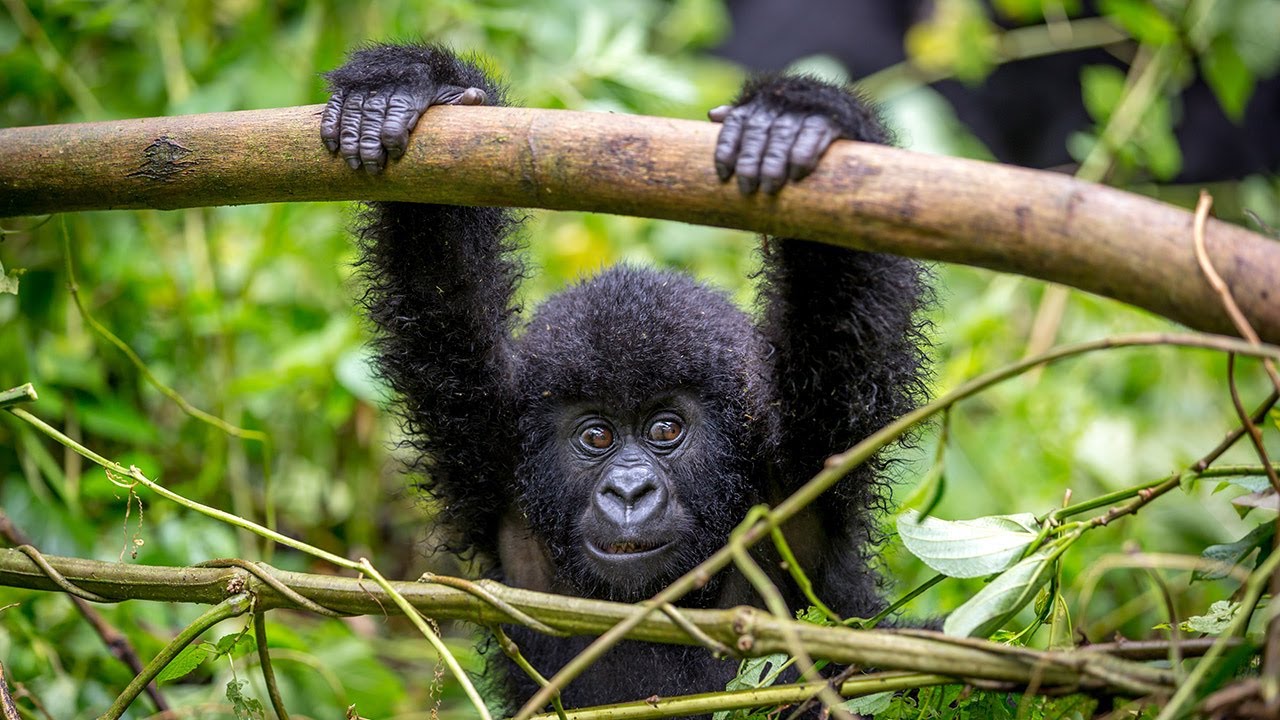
[321,45,521,555]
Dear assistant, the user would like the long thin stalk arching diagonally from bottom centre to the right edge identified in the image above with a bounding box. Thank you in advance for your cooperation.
[512,333,1280,720]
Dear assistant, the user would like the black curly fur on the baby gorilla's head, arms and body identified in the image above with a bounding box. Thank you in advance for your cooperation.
[328,45,928,706]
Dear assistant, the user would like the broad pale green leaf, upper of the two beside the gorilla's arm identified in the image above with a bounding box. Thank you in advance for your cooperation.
[897,510,1039,578]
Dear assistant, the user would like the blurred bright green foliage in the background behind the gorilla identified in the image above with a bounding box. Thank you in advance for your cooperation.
[0,0,1280,717]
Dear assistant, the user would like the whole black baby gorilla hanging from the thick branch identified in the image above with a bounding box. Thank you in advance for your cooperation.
[320,45,927,706]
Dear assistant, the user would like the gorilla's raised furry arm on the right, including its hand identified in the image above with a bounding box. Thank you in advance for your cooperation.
[710,76,928,614]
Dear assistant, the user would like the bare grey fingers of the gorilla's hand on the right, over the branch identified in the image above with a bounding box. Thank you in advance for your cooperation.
[707,94,841,195]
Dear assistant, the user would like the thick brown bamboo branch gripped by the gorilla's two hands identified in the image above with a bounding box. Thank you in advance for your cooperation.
[0,105,1280,342]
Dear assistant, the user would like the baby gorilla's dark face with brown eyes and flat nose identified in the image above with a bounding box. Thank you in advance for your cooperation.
[521,391,748,601]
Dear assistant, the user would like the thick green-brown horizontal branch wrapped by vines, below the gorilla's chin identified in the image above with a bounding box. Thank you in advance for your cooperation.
[0,548,1172,694]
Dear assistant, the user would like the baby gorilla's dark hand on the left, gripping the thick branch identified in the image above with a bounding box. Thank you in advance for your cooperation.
[320,46,488,174]
